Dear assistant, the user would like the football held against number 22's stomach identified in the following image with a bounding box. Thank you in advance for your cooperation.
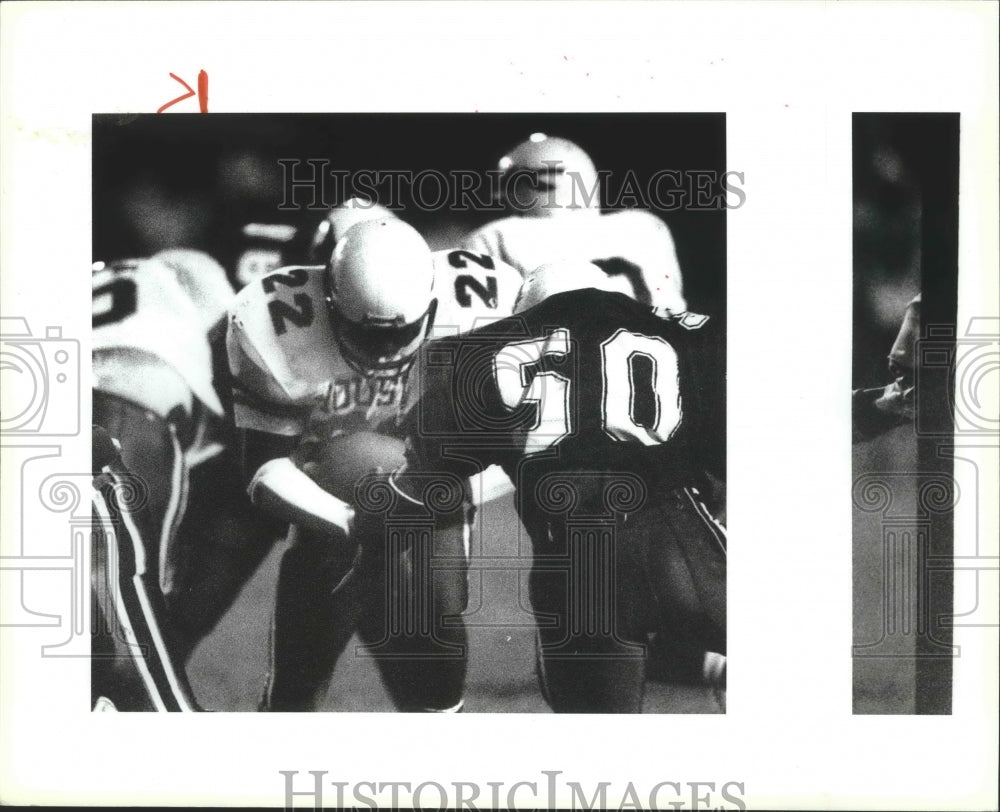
[301,431,406,503]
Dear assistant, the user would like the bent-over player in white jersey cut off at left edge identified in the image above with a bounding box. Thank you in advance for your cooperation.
[92,252,233,594]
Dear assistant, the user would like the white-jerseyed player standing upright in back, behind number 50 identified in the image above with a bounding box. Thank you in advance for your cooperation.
[462,133,687,313]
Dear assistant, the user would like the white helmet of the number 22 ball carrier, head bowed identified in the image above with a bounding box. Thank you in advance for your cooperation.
[326,217,437,374]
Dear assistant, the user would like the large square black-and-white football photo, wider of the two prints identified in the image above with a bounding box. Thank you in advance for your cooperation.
[91,113,728,713]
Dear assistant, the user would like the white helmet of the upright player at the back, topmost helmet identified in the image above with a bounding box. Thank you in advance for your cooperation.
[499,133,601,217]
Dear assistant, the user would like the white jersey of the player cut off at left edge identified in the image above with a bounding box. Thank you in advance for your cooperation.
[92,259,223,417]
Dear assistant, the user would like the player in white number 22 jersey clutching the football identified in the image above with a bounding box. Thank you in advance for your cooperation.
[227,218,521,711]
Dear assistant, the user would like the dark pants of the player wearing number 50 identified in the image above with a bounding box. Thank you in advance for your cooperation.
[531,482,726,713]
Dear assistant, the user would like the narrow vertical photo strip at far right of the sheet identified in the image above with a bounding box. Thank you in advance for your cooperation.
[852,113,960,714]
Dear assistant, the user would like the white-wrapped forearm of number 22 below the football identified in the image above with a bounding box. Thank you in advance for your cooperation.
[247,457,354,534]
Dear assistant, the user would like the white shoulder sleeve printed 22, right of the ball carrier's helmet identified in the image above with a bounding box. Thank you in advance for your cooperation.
[431,249,521,338]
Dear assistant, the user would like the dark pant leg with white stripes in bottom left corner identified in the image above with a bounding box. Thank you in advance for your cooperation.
[91,430,199,711]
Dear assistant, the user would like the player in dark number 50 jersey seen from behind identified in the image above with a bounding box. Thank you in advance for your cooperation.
[356,263,726,713]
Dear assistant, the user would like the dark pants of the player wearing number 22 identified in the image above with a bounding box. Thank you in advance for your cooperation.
[262,498,468,711]
